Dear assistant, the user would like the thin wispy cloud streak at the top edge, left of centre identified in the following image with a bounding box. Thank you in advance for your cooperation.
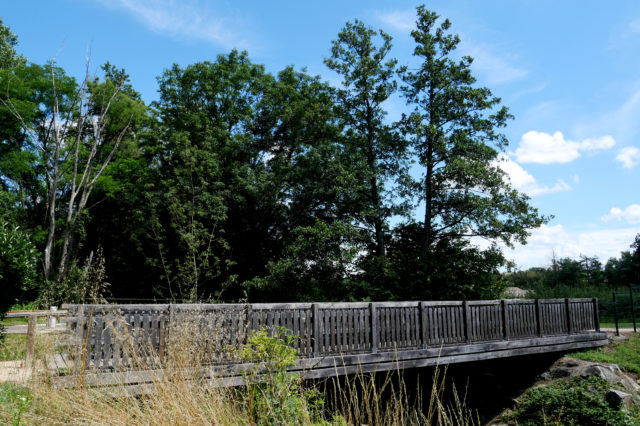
[101,0,249,49]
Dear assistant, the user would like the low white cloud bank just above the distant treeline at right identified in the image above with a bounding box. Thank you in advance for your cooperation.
[503,224,640,269]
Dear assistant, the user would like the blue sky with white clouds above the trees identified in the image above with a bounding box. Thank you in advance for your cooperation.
[0,0,640,268]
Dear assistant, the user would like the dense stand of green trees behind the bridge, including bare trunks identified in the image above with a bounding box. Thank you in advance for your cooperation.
[0,7,548,302]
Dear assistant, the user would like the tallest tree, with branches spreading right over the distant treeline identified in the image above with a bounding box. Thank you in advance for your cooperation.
[402,6,547,256]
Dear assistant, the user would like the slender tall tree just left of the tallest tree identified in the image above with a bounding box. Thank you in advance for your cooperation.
[325,20,403,257]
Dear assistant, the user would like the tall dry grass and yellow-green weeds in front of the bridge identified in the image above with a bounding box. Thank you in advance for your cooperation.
[0,308,479,425]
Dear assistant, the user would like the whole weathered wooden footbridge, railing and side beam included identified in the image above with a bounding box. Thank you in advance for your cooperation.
[52,299,607,392]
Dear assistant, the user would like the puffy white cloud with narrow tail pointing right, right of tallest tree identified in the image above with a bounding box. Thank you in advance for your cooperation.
[515,130,616,164]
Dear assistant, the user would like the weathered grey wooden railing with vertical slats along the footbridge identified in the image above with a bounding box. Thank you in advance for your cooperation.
[64,299,600,368]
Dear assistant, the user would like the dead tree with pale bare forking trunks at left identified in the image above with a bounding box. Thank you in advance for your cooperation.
[1,59,131,282]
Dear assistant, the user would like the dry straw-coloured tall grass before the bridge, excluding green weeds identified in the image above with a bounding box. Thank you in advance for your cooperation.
[0,308,476,425]
